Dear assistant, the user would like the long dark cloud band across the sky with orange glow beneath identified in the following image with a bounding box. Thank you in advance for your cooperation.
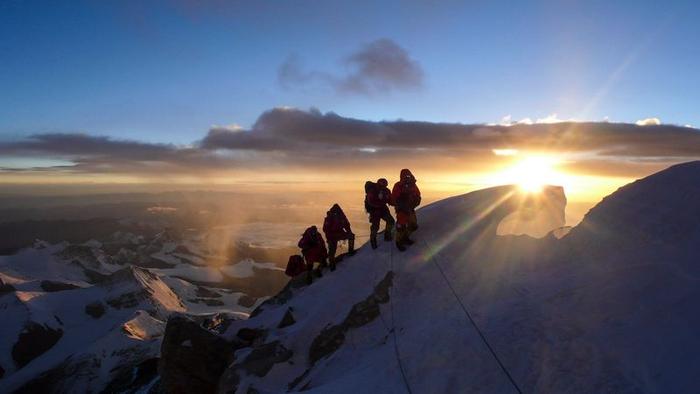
[0,108,700,176]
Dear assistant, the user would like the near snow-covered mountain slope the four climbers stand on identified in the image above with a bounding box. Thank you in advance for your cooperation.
[159,162,700,393]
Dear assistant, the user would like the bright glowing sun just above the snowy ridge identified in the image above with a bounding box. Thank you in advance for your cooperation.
[495,156,568,193]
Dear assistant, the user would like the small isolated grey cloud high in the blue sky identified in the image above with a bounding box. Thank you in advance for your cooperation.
[277,38,424,95]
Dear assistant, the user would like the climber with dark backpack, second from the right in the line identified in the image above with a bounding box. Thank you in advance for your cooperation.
[365,178,395,249]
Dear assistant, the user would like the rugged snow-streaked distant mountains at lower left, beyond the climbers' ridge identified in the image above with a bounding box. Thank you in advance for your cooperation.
[0,228,286,393]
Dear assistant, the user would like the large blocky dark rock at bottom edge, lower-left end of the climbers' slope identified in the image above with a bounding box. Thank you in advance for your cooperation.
[158,315,235,393]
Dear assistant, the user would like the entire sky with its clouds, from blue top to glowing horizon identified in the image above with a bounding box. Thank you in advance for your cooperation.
[0,0,700,203]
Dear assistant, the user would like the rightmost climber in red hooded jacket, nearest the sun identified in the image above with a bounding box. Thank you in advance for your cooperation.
[391,168,421,252]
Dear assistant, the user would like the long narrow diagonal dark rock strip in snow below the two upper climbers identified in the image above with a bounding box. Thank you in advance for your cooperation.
[309,271,394,365]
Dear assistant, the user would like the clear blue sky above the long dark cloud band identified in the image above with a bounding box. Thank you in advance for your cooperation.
[0,0,700,144]
